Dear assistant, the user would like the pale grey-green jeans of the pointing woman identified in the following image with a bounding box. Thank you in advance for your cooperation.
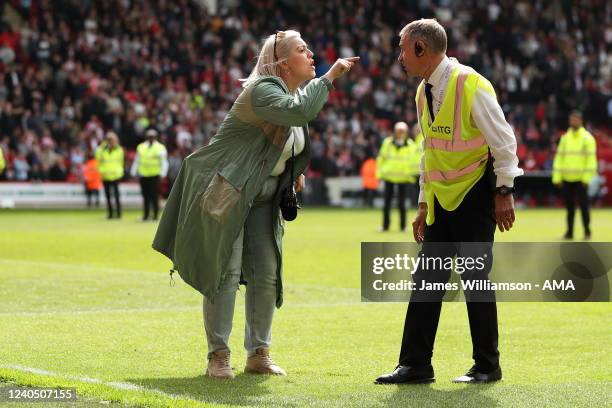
[203,177,278,358]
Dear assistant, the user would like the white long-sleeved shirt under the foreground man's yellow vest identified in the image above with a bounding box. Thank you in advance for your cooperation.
[418,56,523,203]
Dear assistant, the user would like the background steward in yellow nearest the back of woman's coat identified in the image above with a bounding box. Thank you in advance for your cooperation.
[131,129,168,221]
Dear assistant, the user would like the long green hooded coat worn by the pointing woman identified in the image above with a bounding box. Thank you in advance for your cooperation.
[153,76,332,307]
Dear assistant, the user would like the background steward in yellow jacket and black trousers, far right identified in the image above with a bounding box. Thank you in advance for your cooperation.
[552,111,597,239]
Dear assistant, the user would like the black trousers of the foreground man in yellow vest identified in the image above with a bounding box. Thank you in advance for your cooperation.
[399,162,499,372]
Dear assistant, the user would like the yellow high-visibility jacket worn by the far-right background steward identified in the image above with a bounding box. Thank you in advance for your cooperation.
[552,126,597,184]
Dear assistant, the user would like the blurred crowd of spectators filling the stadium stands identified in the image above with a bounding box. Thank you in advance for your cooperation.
[0,0,612,181]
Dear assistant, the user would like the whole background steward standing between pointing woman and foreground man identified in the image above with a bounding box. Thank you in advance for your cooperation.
[376,122,415,232]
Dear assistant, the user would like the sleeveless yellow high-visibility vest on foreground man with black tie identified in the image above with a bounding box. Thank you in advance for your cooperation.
[416,64,495,225]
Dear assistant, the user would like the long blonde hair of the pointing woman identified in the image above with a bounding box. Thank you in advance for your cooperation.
[240,30,302,88]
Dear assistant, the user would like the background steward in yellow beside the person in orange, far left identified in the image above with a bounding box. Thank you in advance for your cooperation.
[95,132,125,220]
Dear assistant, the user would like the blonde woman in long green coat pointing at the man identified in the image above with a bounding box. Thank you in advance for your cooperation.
[153,30,359,378]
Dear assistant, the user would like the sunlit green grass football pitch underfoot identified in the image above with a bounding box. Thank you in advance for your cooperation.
[0,208,612,407]
